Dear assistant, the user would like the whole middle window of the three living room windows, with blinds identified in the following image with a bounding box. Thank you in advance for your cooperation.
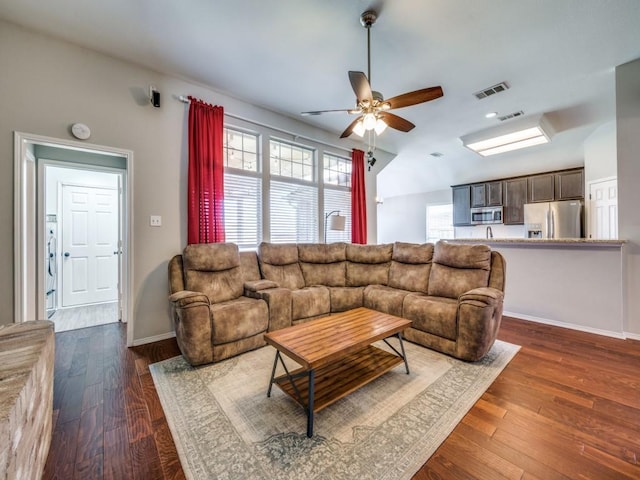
[269,139,319,243]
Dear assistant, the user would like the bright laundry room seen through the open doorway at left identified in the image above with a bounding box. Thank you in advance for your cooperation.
[44,163,122,332]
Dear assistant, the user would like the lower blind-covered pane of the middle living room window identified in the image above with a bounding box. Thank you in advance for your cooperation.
[269,180,318,243]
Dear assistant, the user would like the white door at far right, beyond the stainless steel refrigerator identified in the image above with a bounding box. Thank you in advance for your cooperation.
[589,178,618,240]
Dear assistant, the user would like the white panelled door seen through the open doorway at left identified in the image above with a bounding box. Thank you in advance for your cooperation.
[61,185,119,307]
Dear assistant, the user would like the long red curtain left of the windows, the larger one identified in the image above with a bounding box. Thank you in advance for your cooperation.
[187,97,224,244]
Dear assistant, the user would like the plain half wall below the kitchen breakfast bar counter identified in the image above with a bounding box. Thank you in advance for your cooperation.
[492,244,625,337]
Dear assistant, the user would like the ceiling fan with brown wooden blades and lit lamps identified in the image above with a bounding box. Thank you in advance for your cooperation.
[302,10,443,138]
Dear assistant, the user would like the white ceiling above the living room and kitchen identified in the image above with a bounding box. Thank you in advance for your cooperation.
[0,0,640,197]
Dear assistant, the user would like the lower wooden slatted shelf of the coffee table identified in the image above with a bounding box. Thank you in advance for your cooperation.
[274,345,404,412]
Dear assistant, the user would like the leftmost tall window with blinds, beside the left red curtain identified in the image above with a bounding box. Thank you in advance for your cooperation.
[223,128,262,249]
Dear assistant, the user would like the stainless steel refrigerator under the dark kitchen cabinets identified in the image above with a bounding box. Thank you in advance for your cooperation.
[524,200,583,238]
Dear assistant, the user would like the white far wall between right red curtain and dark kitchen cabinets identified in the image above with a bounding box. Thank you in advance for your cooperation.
[378,189,452,243]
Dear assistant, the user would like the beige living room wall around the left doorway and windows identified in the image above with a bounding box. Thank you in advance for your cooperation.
[0,21,393,340]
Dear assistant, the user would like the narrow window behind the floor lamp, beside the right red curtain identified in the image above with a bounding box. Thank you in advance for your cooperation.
[322,153,351,243]
